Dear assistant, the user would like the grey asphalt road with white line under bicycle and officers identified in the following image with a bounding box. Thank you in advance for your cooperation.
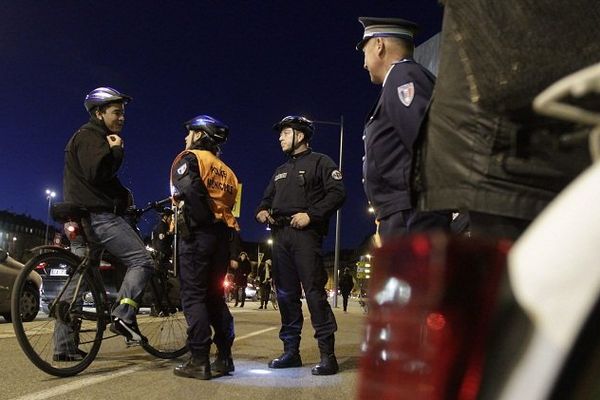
[0,297,364,400]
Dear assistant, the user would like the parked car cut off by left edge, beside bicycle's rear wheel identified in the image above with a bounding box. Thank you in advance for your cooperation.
[0,249,42,322]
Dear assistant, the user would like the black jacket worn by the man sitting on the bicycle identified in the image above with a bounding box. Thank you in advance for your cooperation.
[63,119,130,213]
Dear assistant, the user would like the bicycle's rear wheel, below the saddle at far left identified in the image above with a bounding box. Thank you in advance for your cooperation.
[11,251,106,377]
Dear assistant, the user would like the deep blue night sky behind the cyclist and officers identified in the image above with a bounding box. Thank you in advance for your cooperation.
[0,0,442,248]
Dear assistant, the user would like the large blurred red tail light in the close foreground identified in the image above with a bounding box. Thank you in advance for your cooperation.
[358,235,509,400]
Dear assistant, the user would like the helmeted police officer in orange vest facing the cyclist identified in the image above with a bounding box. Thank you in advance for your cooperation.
[171,115,239,380]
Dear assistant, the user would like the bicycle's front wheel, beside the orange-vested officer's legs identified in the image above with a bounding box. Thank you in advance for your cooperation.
[137,275,188,359]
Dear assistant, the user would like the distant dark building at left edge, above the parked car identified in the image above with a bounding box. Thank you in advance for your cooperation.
[0,210,57,262]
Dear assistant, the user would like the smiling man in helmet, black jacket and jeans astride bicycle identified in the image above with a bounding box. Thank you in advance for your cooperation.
[55,87,154,361]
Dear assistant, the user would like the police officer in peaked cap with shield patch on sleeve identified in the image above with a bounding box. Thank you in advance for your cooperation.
[356,17,451,240]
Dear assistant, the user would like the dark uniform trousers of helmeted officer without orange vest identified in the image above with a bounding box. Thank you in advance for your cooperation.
[272,226,337,354]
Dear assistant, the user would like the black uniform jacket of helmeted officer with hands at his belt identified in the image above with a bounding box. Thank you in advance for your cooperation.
[256,149,346,234]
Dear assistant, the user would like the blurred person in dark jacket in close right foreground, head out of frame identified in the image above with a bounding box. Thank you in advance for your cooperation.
[413,0,600,239]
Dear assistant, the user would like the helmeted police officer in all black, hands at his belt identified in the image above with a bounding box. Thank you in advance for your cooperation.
[256,116,346,375]
